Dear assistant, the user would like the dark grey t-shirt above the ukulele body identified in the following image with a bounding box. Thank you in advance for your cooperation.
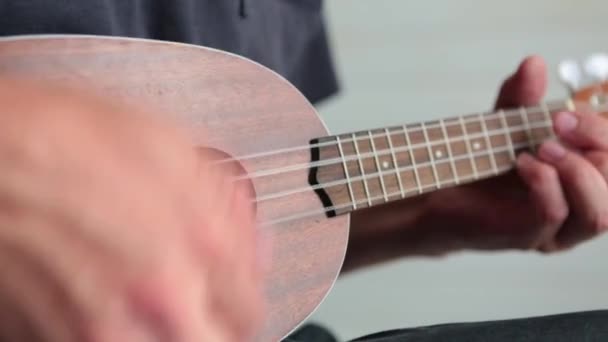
[0,0,338,102]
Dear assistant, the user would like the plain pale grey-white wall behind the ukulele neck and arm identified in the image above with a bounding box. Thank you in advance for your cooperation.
[312,0,608,340]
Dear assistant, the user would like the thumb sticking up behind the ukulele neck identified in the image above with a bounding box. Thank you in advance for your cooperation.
[495,56,547,108]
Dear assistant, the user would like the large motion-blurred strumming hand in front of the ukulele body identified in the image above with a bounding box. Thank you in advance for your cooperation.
[0,80,263,342]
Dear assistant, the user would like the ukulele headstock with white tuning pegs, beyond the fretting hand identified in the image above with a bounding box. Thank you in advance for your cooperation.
[559,54,608,115]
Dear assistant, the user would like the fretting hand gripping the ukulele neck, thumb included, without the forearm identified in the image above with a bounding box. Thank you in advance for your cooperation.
[431,57,608,252]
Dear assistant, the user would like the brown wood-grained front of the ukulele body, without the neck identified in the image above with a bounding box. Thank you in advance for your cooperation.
[0,36,348,341]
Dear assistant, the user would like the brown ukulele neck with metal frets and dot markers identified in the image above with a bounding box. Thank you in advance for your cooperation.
[310,101,574,216]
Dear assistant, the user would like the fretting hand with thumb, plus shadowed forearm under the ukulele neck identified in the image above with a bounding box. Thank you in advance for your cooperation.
[345,57,608,270]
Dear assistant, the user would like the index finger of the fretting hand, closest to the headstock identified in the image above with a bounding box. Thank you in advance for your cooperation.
[553,112,608,151]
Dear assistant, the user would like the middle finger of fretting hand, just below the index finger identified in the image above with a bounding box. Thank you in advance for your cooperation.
[539,141,608,245]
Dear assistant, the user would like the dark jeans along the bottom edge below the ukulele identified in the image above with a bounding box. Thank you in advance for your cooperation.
[285,310,608,342]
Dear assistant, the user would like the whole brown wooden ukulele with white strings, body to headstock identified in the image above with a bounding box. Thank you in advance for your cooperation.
[0,36,608,341]
